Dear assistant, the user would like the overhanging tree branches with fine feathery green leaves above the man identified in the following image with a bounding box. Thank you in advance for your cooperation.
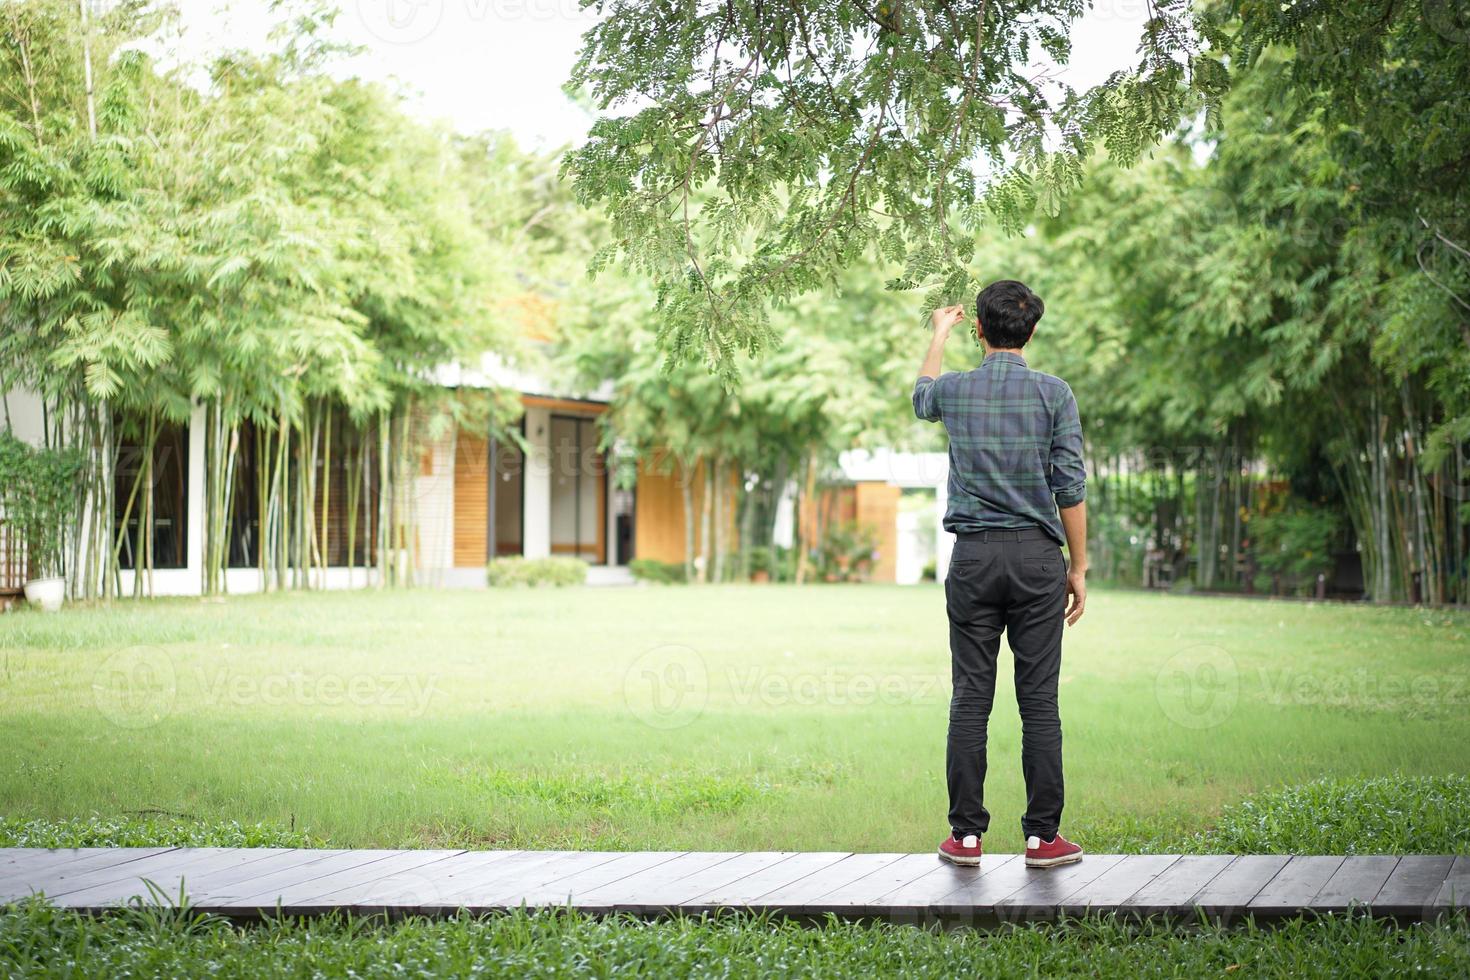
[566,0,1226,381]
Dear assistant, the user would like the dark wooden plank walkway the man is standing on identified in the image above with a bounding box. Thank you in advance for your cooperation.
[0,848,1470,924]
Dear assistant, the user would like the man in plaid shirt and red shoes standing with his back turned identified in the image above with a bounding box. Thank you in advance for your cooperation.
[914,279,1088,867]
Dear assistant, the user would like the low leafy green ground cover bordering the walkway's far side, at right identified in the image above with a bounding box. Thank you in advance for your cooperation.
[1205,776,1470,854]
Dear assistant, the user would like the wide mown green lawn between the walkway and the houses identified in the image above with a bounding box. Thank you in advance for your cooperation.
[0,586,1470,851]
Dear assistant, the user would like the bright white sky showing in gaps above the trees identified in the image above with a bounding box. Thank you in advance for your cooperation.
[179,0,1148,148]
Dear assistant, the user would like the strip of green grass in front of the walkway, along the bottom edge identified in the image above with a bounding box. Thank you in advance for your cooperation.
[0,902,1470,980]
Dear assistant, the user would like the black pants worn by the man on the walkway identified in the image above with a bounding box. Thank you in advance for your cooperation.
[944,529,1067,840]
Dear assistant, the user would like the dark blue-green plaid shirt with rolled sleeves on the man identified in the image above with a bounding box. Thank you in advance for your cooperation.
[914,351,1086,544]
